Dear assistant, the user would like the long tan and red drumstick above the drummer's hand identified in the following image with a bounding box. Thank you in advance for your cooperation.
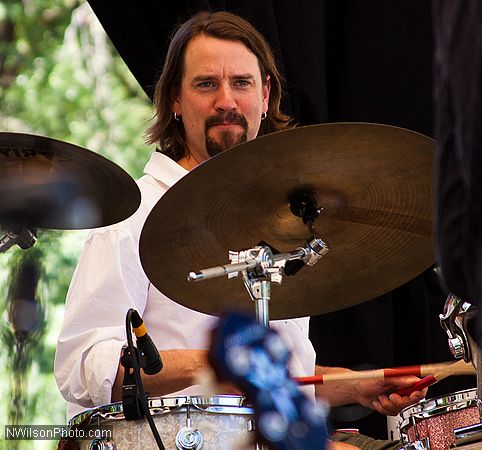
[294,360,475,385]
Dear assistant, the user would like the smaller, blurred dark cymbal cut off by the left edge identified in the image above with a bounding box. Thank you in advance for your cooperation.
[0,132,140,230]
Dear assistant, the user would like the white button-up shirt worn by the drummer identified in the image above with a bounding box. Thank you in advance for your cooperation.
[55,152,315,418]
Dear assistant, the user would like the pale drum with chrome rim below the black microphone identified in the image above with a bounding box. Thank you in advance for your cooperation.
[69,395,256,450]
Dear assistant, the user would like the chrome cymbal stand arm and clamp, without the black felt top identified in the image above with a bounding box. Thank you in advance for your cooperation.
[187,237,329,327]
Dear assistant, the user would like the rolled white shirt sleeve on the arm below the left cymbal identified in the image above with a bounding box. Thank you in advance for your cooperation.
[55,227,149,408]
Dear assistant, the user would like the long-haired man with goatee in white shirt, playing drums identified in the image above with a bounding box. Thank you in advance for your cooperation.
[55,8,424,448]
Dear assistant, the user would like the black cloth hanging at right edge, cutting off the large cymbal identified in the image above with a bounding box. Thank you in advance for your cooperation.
[433,0,482,347]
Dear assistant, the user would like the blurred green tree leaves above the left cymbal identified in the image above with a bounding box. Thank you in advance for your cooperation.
[0,0,151,176]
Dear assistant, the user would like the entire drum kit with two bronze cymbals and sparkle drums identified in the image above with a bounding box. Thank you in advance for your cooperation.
[0,123,482,450]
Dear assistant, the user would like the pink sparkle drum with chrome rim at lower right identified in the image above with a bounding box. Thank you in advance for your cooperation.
[398,389,480,450]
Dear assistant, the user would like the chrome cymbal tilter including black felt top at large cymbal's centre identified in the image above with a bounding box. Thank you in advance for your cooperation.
[187,191,329,327]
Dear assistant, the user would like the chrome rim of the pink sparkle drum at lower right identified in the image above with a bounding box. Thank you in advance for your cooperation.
[399,388,477,430]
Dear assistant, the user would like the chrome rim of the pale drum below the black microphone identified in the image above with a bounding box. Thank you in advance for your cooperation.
[68,395,254,426]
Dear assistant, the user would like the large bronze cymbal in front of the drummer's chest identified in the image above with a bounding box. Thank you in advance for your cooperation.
[140,123,435,319]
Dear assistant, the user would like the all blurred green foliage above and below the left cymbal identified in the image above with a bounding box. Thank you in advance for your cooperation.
[0,0,152,449]
